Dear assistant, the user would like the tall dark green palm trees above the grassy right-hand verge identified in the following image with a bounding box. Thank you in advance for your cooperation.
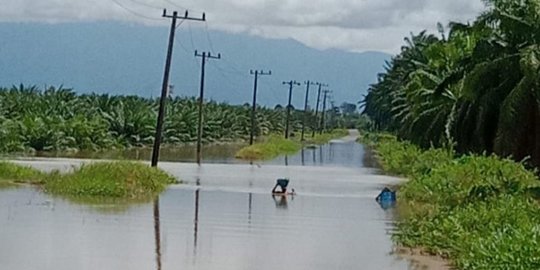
[363,0,540,166]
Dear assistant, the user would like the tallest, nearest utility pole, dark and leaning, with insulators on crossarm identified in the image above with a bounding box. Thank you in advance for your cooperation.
[152,9,206,167]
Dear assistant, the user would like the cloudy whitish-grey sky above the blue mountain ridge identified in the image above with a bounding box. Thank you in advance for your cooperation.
[0,0,485,53]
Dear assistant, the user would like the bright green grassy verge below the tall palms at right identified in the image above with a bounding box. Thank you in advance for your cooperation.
[362,134,540,269]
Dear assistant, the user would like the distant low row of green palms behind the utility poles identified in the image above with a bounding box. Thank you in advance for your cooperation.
[0,85,358,153]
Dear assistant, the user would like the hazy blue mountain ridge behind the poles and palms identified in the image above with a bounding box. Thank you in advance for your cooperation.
[0,22,390,107]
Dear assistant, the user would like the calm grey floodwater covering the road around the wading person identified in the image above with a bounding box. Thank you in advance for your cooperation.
[0,137,448,270]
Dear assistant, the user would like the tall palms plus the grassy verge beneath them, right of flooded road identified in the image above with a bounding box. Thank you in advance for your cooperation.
[363,0,540,269]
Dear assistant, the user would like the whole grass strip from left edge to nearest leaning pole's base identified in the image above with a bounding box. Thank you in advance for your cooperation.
[0,162,176,200]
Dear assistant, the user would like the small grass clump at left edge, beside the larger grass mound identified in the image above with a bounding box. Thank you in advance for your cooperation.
[0,161,45,184]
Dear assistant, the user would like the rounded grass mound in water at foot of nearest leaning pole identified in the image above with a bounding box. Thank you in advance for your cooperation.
[44,162,175,199]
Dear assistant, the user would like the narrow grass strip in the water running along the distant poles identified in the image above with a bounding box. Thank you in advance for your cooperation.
[235,129,348,160]
